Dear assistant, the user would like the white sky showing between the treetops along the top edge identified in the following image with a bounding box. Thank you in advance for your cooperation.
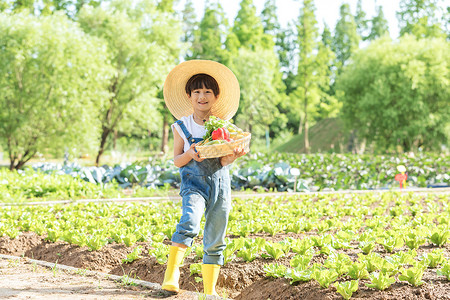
[174,0,414,38]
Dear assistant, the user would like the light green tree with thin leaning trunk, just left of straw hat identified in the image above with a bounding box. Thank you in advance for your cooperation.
[79,1,181,164]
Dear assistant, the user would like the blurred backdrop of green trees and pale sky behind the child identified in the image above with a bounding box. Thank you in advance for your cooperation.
[0,0,450,169]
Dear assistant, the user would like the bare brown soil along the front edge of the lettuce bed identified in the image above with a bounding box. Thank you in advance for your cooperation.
[0,232,450,300]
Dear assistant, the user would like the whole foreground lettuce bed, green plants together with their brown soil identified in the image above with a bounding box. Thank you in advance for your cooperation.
[0,191,450,299]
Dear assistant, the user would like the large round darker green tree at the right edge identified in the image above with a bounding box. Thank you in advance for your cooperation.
[337,36,450,151]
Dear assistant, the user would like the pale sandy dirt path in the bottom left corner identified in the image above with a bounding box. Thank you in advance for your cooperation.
[0,257,198,300]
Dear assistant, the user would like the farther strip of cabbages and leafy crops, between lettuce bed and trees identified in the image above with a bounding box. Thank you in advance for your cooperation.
[0,153,450,202]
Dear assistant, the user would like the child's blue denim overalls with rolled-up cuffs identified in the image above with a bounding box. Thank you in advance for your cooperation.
[172,120,231,265]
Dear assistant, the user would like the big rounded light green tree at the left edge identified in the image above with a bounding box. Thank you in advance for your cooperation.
[0,14,111,169]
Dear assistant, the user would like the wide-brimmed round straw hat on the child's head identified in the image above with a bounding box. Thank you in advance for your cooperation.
[164,60,240,120]
